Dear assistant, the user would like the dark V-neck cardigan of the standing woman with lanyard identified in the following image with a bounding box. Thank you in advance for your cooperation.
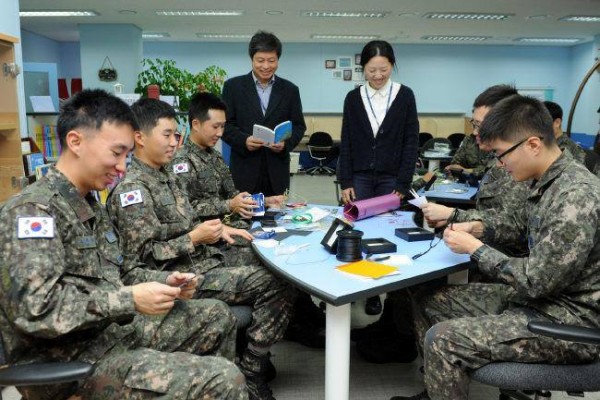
[337,85,419,193]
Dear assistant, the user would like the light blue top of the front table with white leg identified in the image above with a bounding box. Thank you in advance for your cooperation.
[252,207,469,306]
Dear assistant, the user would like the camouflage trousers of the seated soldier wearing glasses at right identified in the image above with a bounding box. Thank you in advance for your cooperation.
[413,283,597,400]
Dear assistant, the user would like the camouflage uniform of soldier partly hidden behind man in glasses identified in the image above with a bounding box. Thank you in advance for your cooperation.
[455,159,531,257]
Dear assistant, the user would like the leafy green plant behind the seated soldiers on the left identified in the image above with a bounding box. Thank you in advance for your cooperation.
[135,58,227,111]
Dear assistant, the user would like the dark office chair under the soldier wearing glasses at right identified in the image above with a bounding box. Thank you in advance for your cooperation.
[471,321,600,400]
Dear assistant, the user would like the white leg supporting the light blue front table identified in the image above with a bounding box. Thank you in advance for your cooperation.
[325,304,350,400]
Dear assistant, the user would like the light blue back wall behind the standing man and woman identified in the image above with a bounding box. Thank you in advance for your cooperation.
[18,34,600,134]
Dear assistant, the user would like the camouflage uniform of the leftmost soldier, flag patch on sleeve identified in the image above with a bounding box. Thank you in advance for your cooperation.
[0,168,247,399]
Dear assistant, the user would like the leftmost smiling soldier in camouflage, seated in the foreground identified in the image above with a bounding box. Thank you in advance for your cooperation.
[0,90,247,400]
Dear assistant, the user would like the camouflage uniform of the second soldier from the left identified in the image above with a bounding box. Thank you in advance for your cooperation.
[107,157,293,348]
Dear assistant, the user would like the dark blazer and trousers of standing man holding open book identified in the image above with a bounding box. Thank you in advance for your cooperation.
[223,73,306,194]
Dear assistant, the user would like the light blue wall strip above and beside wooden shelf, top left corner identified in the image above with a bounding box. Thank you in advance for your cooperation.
[0,0,27,137]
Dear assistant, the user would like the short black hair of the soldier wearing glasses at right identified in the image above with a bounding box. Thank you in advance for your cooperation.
[479,94,554,145]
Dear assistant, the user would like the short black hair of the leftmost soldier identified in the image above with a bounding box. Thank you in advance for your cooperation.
[56,89,138,149]
